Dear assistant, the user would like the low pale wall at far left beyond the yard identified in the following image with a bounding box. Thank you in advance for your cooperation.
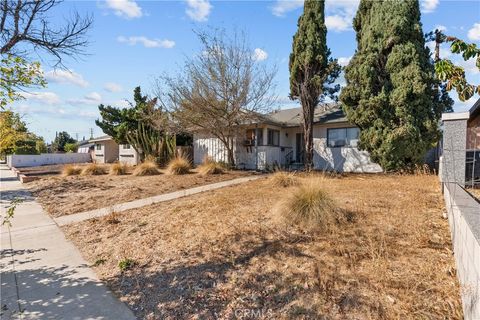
[7,153,91,168]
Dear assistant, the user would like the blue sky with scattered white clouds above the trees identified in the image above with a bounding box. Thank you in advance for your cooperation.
[8,0,480,141]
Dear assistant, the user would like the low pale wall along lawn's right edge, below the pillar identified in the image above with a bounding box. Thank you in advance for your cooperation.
[444,183,480,320]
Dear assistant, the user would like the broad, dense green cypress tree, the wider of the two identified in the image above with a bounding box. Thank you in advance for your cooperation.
[340,0,451,170]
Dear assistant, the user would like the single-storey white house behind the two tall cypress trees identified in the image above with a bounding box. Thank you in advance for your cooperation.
[193,103,382,172]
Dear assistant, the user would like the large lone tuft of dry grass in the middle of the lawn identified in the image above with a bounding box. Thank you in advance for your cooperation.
[280,178,352,231]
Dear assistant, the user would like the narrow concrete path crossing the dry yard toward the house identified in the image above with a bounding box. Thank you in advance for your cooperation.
[54,175,265,226]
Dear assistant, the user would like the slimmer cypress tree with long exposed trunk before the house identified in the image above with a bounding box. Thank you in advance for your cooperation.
[289,0,341,170]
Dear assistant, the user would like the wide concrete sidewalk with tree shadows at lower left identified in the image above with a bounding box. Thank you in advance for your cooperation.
[0,165,135,320]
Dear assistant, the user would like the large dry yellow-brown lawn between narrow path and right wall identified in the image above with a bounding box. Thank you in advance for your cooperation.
[64,175,462,319]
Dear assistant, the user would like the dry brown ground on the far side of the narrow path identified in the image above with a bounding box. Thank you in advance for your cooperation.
[27,171,255,217]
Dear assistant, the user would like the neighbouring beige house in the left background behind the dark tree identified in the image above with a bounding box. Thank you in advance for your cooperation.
[89,135,140,165]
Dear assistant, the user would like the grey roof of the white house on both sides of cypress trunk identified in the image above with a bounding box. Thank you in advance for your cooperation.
[265,103,348,127]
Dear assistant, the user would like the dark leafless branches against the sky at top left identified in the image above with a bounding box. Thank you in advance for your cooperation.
[0,0,93,66]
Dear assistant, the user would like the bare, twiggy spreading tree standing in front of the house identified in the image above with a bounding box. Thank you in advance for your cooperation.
[157,30,276,166]
